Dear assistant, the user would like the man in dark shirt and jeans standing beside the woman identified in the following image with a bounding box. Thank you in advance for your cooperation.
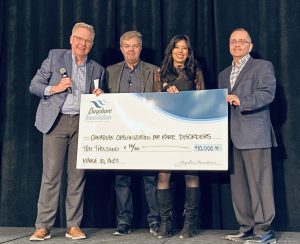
[106,31,159,235]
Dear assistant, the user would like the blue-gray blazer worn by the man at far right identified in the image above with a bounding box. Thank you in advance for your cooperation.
[218,58,277,149]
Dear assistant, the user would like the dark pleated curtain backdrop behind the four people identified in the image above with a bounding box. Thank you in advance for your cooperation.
[0,0,300,231]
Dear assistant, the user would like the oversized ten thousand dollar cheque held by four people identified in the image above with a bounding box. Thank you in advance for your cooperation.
[77,89,228,170]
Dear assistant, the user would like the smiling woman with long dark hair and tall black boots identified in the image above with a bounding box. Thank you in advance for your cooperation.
[156,35,204,238]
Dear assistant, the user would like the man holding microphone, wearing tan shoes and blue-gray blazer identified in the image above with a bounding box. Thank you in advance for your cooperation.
[29,23,105,241]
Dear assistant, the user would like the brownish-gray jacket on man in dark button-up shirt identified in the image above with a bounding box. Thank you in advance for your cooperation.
[106,61,158,93]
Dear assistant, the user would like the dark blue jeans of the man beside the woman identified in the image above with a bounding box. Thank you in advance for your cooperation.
[115,172,159,226]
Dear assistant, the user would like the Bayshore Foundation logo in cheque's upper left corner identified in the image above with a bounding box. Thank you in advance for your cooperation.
[85,99,112,121]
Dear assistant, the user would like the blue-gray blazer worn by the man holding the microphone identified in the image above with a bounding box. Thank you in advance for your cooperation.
[29,49,105,133]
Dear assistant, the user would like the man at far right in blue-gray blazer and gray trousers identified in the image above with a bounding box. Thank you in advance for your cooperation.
[219,28,277,243]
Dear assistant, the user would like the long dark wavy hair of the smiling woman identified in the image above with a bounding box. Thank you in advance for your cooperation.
[160,35,197,79]
